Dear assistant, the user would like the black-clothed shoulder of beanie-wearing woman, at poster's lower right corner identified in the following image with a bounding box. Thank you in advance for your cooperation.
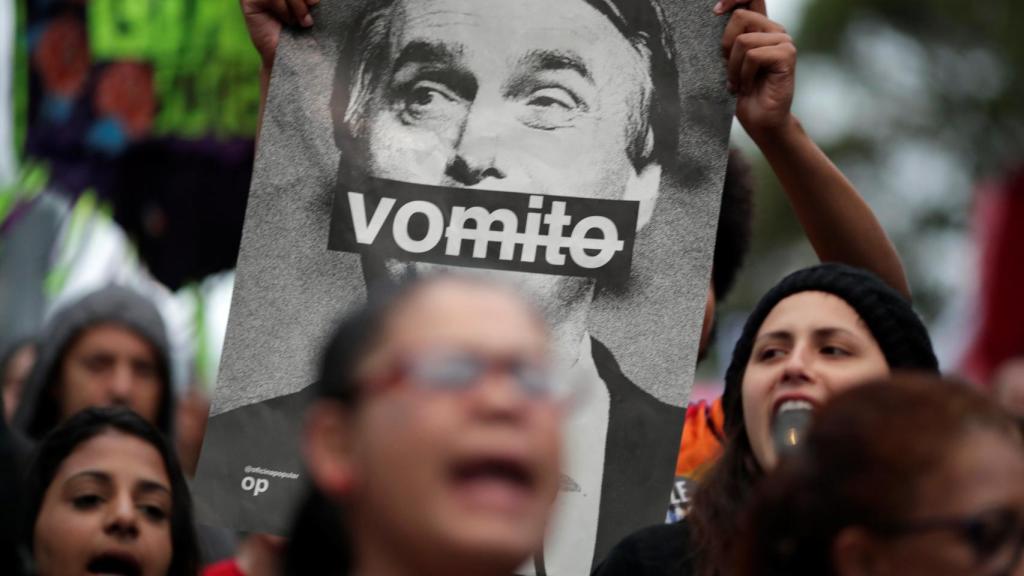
[592,521,693,576]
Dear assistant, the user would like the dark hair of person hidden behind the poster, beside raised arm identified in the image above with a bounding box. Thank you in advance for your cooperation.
[711,148,754,301]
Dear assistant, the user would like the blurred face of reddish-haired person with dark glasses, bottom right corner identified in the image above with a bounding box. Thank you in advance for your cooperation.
[842,428,1024,576]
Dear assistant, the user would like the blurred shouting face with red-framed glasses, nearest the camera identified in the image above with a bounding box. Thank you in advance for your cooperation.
[310,279,561,574]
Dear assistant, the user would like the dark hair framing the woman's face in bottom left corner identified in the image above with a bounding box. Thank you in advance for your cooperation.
[20,407,199,576]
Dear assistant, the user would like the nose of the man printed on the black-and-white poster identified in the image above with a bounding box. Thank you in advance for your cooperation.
[444,101,508,187]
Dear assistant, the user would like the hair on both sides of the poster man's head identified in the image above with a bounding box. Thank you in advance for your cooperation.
[331,0,680,170]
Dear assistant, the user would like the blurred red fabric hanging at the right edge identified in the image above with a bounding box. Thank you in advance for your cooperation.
[963,167,1024,383]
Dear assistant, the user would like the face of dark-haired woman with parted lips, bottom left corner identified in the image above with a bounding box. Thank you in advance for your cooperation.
[33,430,172,576]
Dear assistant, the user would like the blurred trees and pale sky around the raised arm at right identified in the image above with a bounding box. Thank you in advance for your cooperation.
[705,0,1024,376]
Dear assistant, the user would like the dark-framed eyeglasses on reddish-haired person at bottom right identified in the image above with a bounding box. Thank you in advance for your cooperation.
[876,507,1024,576]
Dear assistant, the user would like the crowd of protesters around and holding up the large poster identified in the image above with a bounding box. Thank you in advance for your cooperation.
[0,0,1024,576]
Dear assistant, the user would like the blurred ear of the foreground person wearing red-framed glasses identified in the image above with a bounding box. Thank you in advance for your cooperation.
[302,400,355,500]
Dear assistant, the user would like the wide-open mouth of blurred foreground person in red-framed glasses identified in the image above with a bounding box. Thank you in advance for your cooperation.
[452,456,537,511]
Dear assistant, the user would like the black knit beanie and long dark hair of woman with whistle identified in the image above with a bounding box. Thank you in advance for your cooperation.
[688,263,938,575]
